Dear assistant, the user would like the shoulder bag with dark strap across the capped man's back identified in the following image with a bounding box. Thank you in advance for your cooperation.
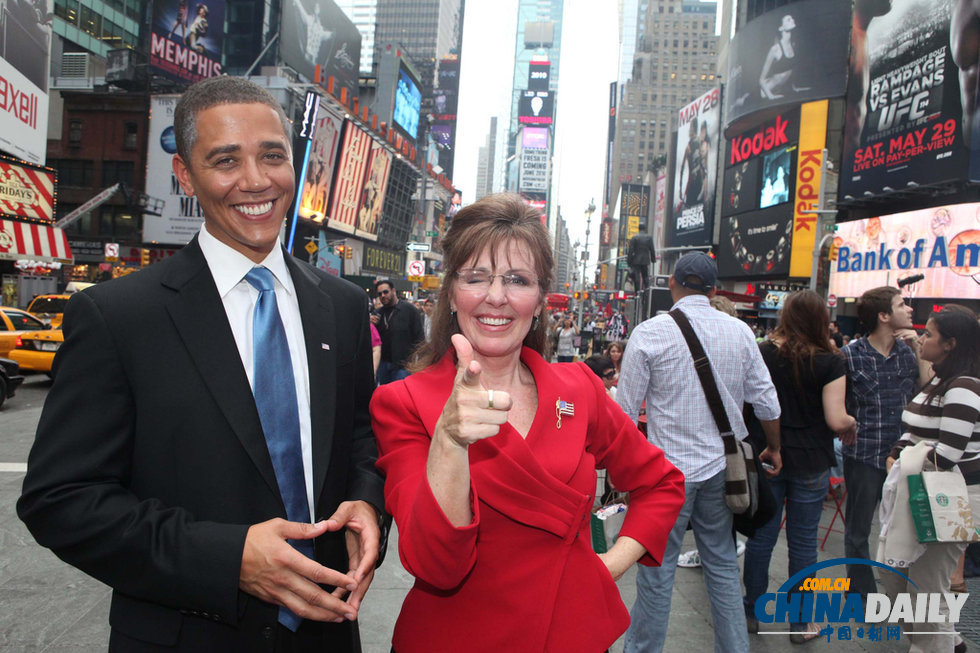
[669,308,759,516]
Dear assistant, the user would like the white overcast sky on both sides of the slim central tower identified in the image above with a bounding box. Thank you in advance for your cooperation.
[452,0,619,270]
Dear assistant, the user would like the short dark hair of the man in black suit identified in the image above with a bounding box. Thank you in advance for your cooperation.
[174,75,292,162]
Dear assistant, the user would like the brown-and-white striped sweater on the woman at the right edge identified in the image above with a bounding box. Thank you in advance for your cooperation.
[890,376,980,485]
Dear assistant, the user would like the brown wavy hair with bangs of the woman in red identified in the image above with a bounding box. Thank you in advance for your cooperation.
[408,193,555,372]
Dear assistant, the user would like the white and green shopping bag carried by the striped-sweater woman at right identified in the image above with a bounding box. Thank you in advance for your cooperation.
[908,449,980,544]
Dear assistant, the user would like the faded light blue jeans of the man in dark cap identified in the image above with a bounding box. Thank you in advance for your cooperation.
[624,470,749,653]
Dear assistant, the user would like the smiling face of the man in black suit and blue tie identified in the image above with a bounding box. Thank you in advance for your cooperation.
[173,103,295,263]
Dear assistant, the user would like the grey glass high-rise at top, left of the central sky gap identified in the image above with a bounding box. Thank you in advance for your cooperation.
[374,0,463,109]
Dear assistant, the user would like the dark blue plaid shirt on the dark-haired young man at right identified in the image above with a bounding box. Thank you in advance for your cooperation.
[841,338,919,469]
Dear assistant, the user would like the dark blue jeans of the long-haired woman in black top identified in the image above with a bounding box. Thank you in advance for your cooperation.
[743,470,830,630]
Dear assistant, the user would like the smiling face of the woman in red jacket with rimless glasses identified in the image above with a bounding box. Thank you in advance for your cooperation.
[450,240,543,358]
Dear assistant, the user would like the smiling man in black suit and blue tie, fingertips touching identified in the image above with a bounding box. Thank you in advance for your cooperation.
[17,77,383,652]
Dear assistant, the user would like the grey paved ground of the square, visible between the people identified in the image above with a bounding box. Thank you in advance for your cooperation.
[0,375,980,653]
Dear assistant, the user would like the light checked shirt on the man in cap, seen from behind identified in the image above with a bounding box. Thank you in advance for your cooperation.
[616,295,779,481]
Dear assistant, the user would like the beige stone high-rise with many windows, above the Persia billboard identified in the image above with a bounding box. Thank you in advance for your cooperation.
[607,0,718,191]
